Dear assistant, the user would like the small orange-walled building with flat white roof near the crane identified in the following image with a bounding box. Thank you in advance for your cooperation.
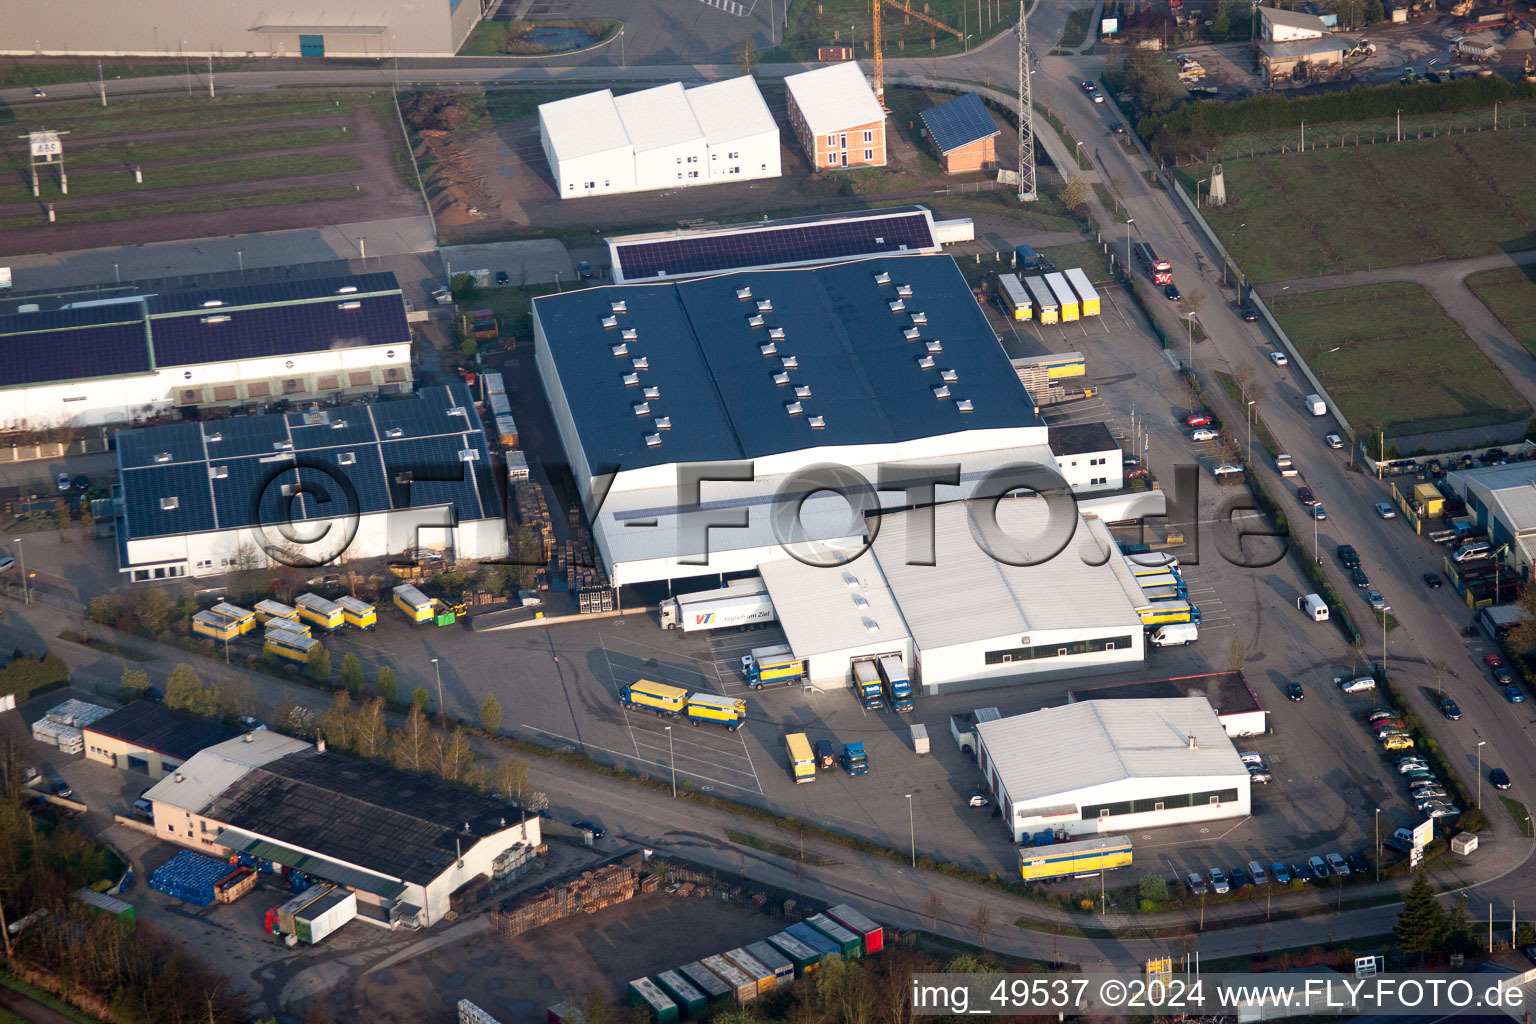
[783,60,886,170]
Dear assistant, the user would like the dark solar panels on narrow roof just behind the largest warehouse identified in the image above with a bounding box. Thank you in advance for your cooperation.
[614,210,935,281]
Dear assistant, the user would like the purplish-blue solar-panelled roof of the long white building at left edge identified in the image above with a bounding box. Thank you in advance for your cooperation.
[0,273,410,387]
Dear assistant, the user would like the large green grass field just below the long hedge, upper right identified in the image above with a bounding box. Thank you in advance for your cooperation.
[1180,130,1536,282]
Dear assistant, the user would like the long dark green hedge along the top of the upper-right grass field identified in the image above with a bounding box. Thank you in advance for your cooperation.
[1137,75,1536,143]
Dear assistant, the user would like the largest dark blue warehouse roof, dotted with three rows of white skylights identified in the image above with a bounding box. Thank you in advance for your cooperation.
[535,255,1040,473]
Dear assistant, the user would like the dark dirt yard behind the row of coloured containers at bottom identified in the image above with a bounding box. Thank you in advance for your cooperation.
[350,894,788,1024]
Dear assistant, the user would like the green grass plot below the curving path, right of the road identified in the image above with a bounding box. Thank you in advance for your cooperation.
[1269,284,1530,433]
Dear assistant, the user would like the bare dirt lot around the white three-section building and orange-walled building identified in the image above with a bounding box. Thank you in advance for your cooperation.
[422,83,1017,243]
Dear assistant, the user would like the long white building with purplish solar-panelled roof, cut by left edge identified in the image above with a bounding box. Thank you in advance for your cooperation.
[0,273,412,430]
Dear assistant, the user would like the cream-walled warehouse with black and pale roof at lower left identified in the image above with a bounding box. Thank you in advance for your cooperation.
[144,732,542,927]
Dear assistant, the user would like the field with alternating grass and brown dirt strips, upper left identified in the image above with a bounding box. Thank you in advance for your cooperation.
[0,94,422,253]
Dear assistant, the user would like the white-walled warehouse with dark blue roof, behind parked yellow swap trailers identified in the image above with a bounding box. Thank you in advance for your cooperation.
[115,384,507,582]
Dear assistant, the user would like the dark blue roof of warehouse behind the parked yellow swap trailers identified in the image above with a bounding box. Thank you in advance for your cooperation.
[117,384,501,539]
